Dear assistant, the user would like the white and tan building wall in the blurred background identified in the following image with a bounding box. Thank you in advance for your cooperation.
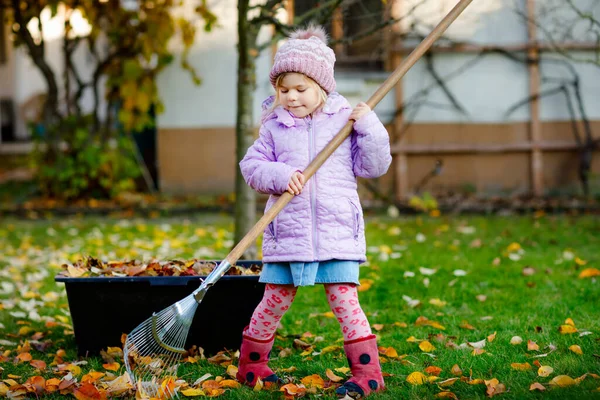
[159,0,600,194]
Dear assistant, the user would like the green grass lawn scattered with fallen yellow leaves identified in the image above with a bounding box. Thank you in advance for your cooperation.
[0,215,600,399]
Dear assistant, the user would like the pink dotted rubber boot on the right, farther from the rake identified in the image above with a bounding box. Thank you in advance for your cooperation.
[336,335,385,399]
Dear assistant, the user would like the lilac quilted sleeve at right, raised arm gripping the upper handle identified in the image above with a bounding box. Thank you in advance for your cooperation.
[351,111,392,178]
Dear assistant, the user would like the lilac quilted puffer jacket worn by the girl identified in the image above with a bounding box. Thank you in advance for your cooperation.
[240,93,392,262]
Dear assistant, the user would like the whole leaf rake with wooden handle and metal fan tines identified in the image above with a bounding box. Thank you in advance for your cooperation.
[124,0,472,398]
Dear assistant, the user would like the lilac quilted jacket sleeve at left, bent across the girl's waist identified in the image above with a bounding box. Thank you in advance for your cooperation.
[240,125,298,195]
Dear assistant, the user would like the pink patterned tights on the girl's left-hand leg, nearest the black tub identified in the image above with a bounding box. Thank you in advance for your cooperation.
[246,283,298,339]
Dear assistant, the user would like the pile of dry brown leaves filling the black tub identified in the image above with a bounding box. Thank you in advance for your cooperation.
[58,257,261,278]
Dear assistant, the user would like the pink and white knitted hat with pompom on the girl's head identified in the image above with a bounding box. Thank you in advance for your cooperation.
[269,25,335,93]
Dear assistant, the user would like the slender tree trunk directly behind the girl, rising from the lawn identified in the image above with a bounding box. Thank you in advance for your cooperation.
[234,0,257,259]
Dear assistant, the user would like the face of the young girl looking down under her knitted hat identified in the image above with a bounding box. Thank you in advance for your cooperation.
[277,72,321,118]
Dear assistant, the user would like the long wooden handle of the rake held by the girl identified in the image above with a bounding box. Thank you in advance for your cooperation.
[225,0,472,265]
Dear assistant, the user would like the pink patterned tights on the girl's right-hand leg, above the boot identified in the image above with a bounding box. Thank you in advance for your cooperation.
[324,283,371,341]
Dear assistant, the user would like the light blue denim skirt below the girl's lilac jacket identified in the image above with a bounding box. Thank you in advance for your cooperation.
[259,260,360,286]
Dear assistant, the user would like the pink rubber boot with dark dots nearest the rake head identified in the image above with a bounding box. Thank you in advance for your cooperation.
[236,328,279,387]
